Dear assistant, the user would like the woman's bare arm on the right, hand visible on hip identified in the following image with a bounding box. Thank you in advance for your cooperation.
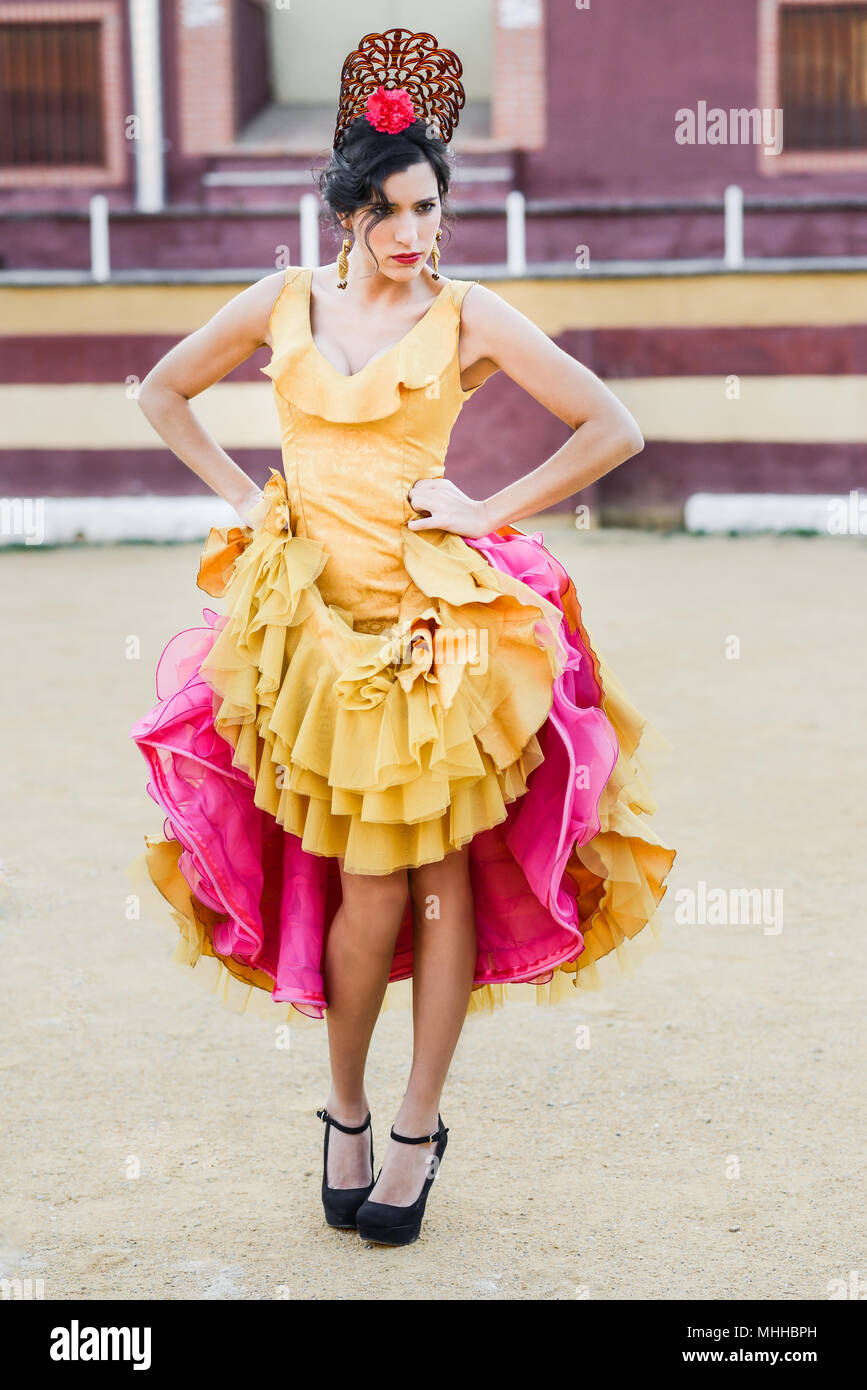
[408,285,645,537]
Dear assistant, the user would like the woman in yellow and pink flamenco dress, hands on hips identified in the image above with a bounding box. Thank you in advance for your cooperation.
[131,31,674,1244]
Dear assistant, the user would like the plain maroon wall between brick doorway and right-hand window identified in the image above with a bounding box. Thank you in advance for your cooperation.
[525,0,867,197]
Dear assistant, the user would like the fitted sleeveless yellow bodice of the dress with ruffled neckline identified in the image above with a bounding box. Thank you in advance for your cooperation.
[261,265,489,626]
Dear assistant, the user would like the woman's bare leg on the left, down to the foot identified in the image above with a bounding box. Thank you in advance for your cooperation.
[322,859,407,1187]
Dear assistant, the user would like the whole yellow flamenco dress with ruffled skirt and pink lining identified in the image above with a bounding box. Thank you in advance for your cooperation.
[129,267,674,1020]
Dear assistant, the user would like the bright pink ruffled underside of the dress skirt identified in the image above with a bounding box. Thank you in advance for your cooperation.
[129,532,618,1017]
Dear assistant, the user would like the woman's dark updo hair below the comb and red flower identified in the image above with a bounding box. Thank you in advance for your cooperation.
[317,115,453,275]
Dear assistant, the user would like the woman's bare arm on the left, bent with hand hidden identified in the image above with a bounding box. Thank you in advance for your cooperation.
[138,271,283,520]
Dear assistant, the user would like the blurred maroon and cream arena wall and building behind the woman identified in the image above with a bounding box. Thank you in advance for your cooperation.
[0,0,867,543]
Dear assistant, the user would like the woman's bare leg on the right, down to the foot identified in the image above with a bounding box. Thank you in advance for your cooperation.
[371,845,477,1207]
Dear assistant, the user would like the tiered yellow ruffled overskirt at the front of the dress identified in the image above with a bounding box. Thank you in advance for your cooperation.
[199,470,563,874]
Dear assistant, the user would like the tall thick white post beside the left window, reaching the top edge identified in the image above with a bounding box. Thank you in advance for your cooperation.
[129,0,165,213]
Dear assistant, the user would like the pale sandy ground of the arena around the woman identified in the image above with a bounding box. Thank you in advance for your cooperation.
[0,516,867,1300]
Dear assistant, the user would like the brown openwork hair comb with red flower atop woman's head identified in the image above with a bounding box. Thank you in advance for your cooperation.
[333,29,467,149]
